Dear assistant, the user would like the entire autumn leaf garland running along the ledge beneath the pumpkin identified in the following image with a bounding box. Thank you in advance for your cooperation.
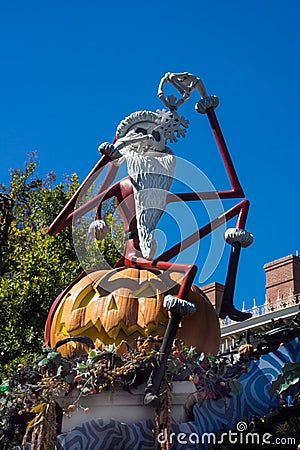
[0,315,300,450]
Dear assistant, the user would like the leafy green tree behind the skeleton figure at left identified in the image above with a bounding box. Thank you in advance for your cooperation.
[0,154,119,380]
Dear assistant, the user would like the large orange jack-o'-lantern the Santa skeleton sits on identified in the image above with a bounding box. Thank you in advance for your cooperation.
[46,268,220,354]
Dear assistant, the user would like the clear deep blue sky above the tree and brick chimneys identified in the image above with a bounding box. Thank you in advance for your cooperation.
[0,0,300,307]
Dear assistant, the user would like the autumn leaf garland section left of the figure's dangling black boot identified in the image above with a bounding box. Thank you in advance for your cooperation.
[0,336,158,450]
